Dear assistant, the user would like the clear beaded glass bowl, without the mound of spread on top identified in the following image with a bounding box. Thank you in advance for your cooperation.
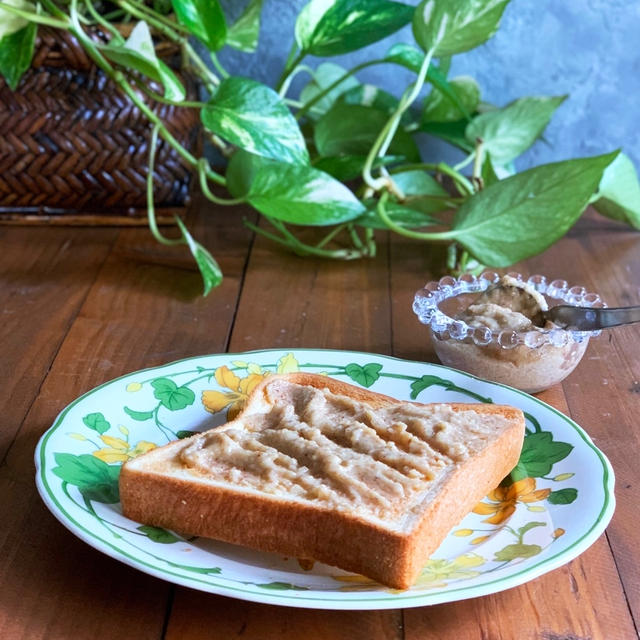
[413,271,606,393]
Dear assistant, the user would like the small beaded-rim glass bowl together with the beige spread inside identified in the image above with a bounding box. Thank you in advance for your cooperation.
[413,271,605,393]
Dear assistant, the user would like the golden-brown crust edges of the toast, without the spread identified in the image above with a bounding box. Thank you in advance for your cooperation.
[120,373,524,589]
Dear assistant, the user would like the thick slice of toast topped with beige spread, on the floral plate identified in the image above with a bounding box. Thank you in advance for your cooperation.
[120,373,524,589]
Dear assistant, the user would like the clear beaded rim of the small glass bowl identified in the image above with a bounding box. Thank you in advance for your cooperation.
[413,271,607,349]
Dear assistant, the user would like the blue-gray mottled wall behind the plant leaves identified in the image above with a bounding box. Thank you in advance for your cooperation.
[221,0,640,170]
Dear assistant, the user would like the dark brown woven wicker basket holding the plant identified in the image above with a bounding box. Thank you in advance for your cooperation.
[0,28,199,224]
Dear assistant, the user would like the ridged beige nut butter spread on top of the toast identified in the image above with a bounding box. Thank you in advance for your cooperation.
[179,381,505,521]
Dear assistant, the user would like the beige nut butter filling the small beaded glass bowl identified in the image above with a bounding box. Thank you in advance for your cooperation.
[434,276,588,393]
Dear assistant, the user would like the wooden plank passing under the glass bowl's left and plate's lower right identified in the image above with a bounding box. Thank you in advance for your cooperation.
[391,218,637,640]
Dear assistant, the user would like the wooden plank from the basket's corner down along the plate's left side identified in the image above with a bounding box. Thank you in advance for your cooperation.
[0,198,251,639]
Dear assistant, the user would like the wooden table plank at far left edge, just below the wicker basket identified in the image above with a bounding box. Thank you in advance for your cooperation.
[0,228,118,460]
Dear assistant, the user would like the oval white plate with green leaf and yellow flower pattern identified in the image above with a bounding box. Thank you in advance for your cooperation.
[35,349,614,609]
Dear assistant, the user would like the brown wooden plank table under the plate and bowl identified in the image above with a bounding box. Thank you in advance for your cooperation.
[0,198,640,640]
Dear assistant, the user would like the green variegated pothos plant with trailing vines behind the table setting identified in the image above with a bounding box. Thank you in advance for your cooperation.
[0,0,640,293]
